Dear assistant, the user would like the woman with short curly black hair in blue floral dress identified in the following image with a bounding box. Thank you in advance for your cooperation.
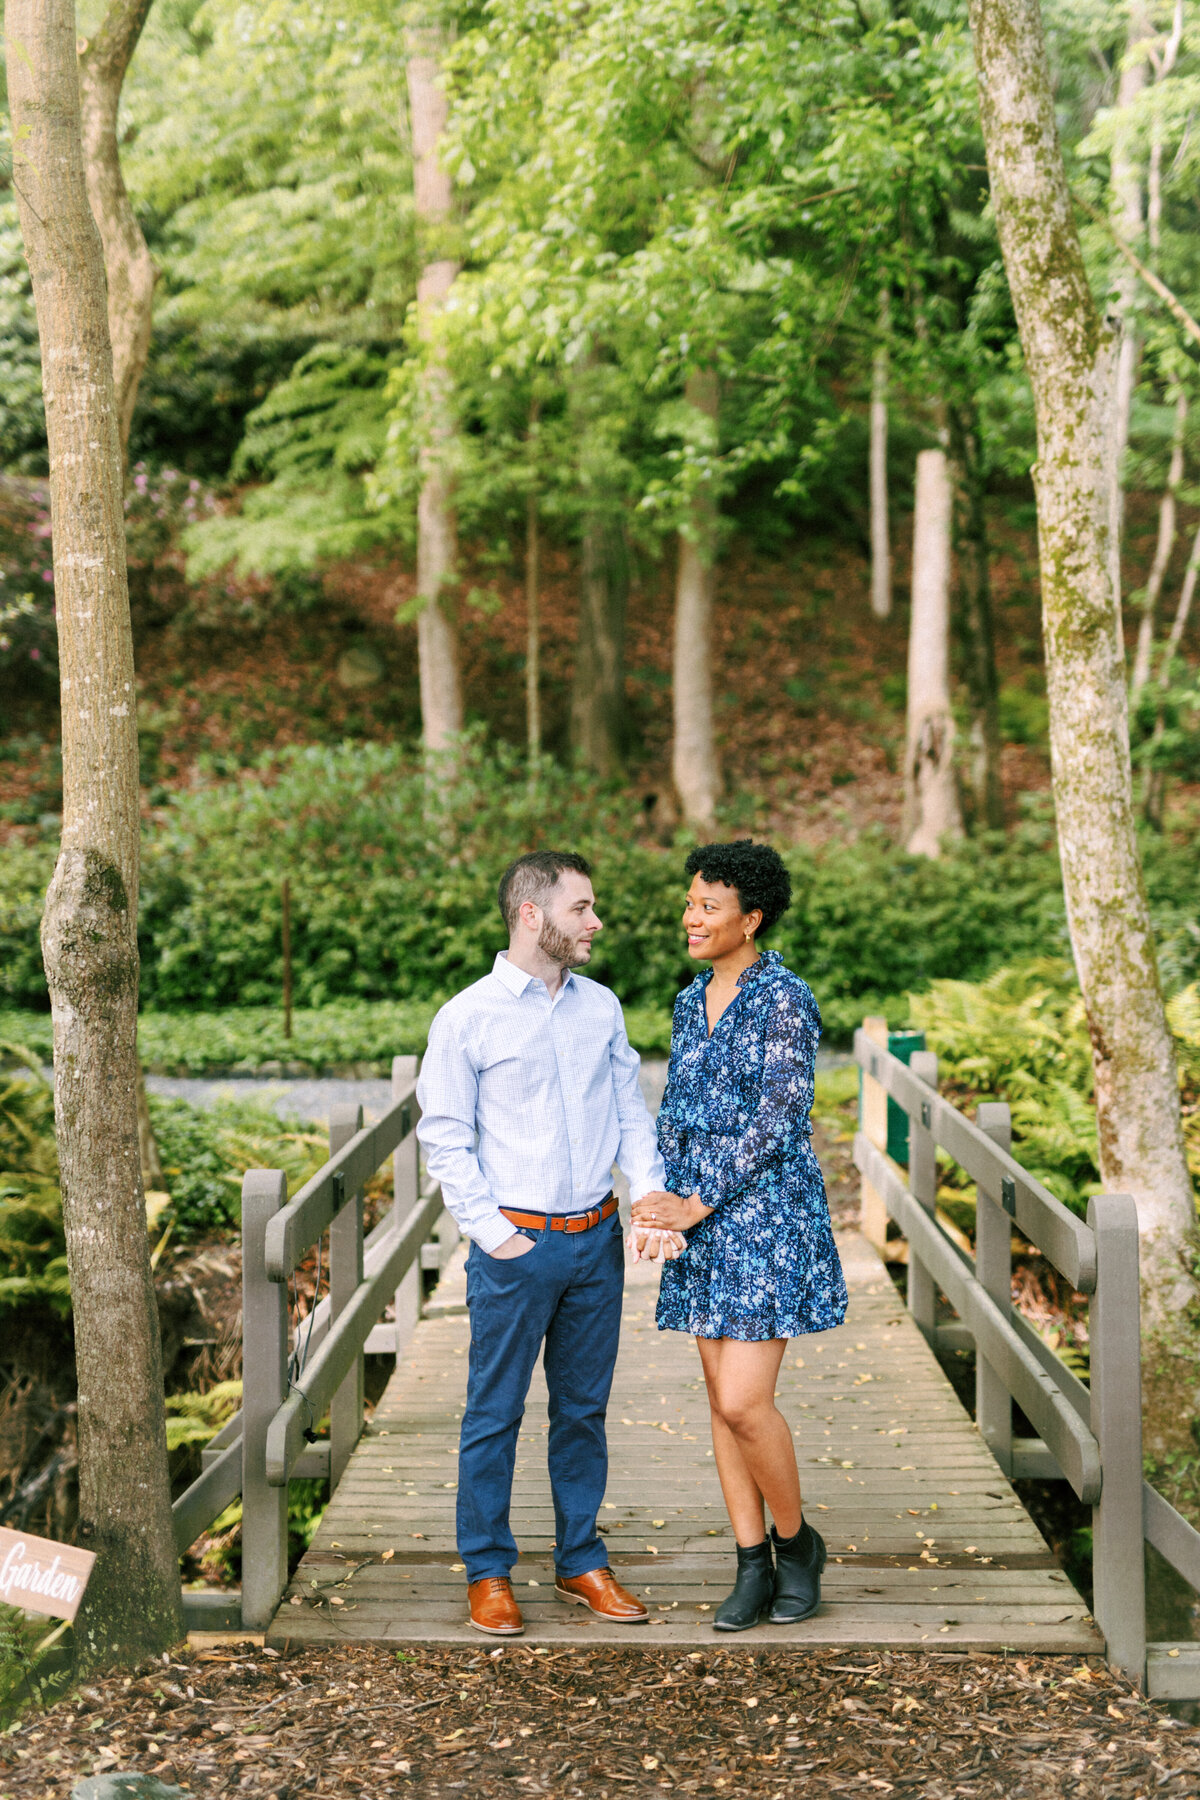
[633,839,846,1631]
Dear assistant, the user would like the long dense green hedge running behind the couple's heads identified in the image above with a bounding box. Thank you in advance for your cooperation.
[9,742,1200,1036]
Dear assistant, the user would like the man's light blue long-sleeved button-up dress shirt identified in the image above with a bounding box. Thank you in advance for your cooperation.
[417,952,662,1251]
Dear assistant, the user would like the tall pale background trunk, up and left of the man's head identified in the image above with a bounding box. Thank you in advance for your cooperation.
[407,25,462,751]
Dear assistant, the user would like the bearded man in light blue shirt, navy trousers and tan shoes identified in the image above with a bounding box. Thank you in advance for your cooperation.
[417,850,662,1636]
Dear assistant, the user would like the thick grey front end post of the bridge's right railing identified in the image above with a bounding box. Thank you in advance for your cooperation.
[1087,1193,1146,1687]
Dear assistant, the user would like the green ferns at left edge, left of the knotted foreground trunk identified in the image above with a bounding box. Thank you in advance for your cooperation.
[0,1044,70,1319]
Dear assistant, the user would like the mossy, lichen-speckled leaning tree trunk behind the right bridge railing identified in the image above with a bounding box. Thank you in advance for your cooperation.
[970,0,1195,1328]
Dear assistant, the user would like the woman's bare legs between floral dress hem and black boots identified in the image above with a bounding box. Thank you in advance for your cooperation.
[696,1337,802,1548]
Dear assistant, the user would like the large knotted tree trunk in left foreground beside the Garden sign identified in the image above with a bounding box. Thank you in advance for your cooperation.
[5,0,184,1667]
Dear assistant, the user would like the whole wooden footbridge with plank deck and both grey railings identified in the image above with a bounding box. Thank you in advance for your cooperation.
[176,1021,1200,1697]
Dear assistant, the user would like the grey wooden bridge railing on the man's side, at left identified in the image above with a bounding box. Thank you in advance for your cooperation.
[173,1057,457,1631]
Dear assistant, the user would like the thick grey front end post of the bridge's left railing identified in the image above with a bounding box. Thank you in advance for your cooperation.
[241,1168,288,1631]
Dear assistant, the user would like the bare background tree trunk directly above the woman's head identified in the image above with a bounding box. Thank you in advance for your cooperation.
[671,369,721,833]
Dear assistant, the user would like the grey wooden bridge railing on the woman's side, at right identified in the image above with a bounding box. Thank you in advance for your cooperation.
[855,1019,1200,1699]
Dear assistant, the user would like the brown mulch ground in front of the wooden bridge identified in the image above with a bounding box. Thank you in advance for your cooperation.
[0,1642,1200,1800]
